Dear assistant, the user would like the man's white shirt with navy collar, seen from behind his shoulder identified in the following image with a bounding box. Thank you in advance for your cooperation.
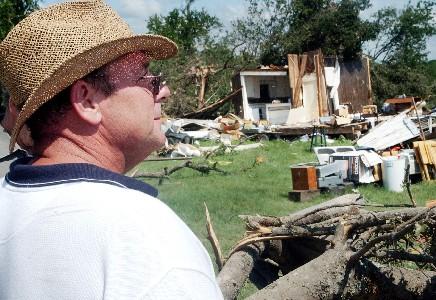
[0,158,222,300]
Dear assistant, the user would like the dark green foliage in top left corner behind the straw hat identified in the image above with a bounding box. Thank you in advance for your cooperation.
[0,0,39,110]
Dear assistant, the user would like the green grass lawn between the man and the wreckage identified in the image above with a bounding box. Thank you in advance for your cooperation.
[135,140,436,296]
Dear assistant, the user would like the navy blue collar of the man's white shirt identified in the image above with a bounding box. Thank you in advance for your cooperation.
[5,157,158,197]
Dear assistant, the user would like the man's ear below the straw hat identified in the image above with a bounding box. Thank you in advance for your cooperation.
[70,79,102,125]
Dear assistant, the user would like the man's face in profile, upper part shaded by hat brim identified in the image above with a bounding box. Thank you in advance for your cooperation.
[101,52,169,169]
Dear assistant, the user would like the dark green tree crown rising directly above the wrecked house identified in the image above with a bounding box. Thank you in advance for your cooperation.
[235,0,376,64]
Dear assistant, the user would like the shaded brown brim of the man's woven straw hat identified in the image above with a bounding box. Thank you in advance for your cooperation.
[9,34,177,152]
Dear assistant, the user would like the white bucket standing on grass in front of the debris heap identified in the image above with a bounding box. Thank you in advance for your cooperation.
[382,156,406,192]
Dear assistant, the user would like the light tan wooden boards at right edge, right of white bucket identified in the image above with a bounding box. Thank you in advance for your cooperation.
[413,141,436,181]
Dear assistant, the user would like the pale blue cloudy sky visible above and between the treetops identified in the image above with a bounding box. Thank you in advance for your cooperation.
[41,0,436,59]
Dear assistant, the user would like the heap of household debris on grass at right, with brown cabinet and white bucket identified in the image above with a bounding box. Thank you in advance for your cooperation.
[289,96,436,197]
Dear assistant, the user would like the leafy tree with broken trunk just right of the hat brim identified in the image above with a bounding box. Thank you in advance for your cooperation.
[147,0,252,116]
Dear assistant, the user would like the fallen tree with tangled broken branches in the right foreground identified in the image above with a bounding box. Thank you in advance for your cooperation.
[215,194,436,300]
